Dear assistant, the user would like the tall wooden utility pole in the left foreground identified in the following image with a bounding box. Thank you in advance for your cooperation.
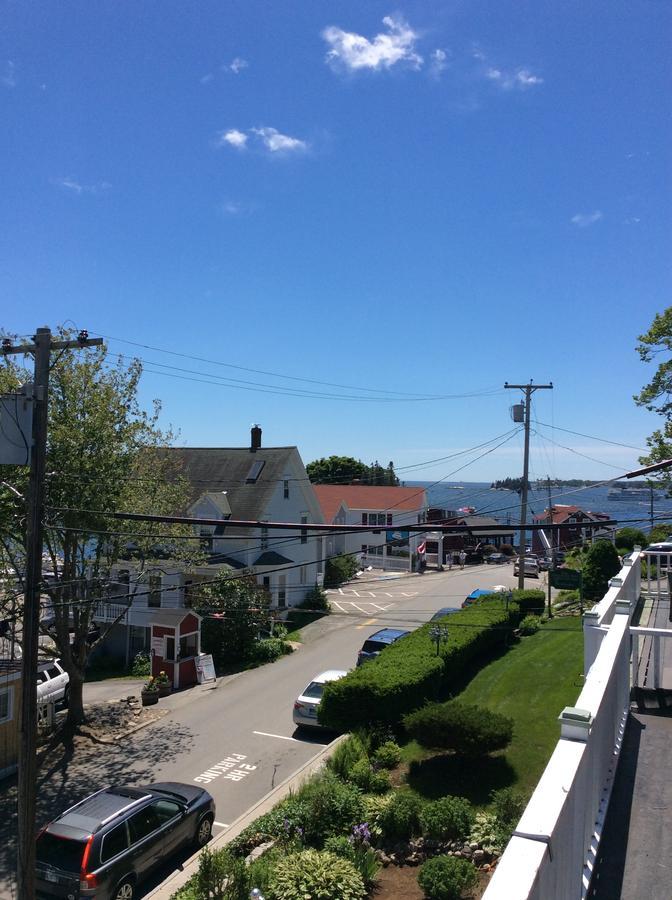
[0,328,102,900]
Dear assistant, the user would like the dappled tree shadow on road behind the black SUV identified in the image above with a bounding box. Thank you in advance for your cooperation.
[0,722,194,900]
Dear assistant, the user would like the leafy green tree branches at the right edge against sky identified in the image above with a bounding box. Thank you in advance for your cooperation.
[634,306,672,491]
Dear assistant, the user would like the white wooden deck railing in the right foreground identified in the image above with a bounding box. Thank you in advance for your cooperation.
[484,553,641,900]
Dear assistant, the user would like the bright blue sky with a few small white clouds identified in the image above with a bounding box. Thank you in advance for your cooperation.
[0,0,672,480]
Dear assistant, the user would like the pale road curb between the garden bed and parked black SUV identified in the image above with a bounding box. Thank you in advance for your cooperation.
[145,734,348,900]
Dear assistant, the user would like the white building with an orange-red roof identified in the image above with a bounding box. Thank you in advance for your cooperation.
[314,484,428,569]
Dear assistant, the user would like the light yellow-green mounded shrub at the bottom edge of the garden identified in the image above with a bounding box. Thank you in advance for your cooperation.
[270,850,366,900]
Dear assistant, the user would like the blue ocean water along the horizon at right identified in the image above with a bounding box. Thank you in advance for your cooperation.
[404,481,672,533]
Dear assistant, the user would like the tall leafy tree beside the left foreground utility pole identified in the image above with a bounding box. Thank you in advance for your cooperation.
[0,332,196,725]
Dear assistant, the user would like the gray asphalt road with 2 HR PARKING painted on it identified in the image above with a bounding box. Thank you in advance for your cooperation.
[0,564,542,898]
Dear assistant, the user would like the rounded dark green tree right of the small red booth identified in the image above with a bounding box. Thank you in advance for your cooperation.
[194,572,270,668]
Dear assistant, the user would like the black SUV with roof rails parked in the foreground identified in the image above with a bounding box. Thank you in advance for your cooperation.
[35,782,215,900]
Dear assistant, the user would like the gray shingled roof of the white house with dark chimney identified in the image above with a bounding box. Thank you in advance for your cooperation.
[163,447,296,533]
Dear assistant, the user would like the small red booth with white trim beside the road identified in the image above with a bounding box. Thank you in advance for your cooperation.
[149,609,201,688]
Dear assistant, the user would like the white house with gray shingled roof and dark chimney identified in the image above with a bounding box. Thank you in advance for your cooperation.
[96,426,326,659]
